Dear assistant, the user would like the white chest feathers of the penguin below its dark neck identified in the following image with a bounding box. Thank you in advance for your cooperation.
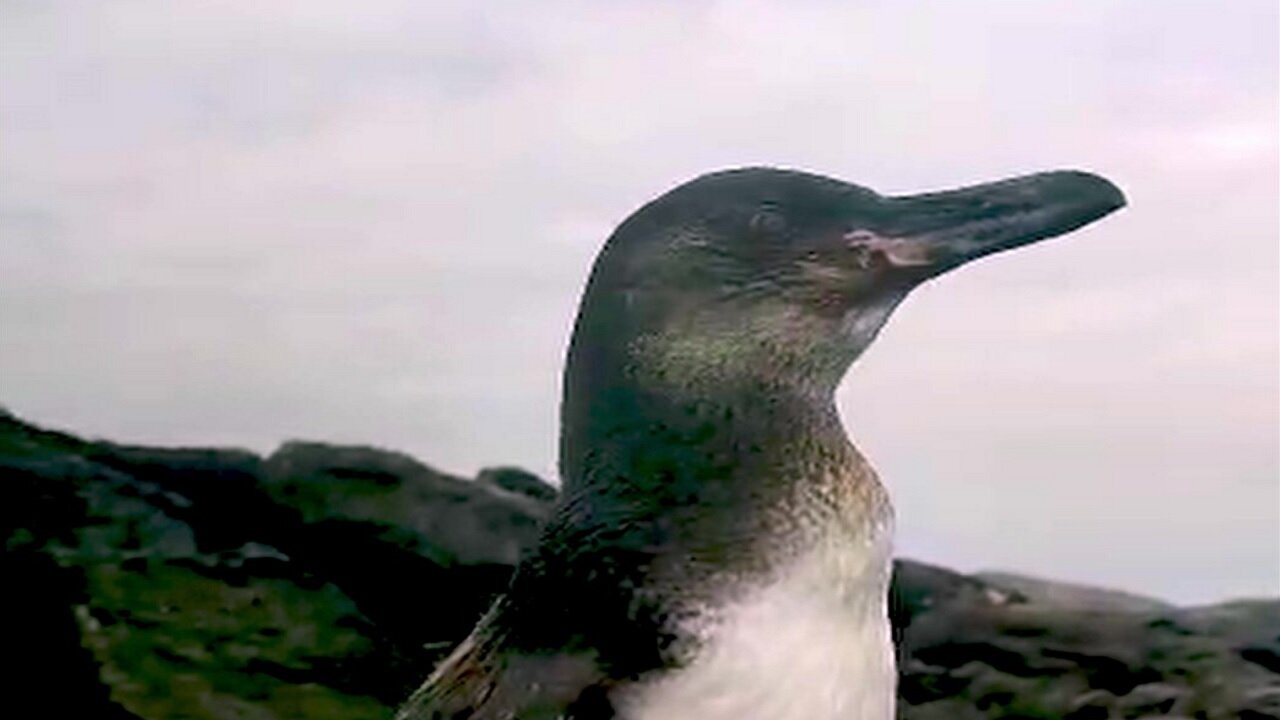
[616,533,897,720]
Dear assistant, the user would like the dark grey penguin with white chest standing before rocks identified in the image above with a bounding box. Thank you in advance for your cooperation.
[397,168,1125,720]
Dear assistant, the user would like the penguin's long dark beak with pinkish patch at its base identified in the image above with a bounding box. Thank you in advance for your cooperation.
[865,170,1125,282]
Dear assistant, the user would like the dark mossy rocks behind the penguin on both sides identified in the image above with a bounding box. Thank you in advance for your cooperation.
[0,414,1280,720]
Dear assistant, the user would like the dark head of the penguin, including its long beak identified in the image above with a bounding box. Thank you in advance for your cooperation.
[576,168,1125,388]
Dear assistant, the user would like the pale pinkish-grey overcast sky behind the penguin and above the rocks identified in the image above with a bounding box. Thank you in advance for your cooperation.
[0,0,1280,602]
